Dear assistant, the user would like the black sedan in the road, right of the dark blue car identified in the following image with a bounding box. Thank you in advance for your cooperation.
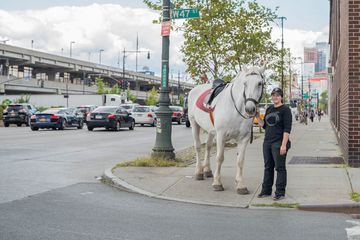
[87,106,135,131]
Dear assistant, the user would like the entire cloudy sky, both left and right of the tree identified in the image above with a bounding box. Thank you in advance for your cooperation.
[0,0,329,77]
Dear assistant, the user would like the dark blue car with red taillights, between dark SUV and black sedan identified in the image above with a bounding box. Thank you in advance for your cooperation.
[30,108,84,131]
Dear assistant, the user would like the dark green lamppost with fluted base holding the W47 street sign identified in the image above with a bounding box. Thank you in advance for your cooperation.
[152,0,175,159]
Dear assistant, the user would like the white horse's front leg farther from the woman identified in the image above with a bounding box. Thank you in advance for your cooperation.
[212,133,225,191]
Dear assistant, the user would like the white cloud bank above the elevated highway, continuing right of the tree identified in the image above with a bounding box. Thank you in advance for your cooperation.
[0,4,327,76]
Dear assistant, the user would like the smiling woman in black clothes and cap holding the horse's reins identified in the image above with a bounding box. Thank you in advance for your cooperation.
[256,88,292,200]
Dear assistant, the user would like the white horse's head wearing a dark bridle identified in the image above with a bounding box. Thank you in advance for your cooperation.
[241,67,265,116]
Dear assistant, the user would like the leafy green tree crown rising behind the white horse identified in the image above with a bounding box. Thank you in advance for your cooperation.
[144,0,279,82]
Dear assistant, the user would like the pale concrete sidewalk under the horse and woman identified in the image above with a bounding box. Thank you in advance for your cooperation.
[105,118,360,208]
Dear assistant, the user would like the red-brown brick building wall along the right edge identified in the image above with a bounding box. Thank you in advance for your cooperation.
[329,0,360,167]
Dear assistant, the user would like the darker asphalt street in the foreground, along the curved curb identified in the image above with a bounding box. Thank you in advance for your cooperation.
[0,183,352,240]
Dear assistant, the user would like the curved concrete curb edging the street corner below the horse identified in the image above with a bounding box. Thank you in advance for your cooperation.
[102,168,249,209]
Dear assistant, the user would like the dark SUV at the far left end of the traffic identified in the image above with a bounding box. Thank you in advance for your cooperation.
[3,104,36,127]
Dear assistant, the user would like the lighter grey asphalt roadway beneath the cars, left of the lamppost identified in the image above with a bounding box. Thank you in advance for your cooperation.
[0,124,192,203]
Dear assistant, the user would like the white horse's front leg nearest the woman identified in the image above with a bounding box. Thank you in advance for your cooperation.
[236,136,250,195]
